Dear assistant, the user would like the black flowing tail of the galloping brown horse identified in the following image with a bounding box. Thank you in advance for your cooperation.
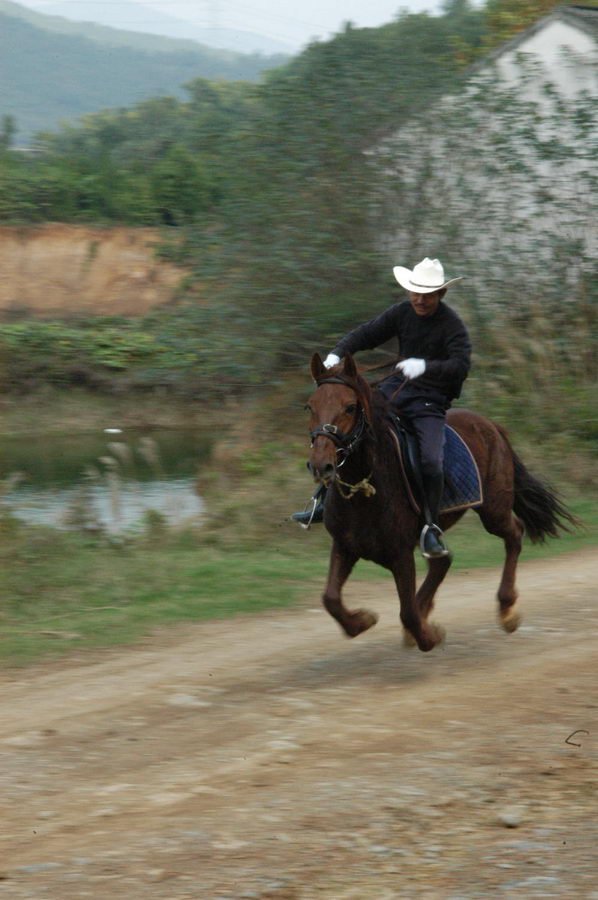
[499,428,581,544]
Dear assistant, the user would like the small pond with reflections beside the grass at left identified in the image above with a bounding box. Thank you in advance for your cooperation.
[0,428,210,532]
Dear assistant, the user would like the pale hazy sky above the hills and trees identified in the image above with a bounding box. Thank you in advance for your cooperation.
[17,0,452,48]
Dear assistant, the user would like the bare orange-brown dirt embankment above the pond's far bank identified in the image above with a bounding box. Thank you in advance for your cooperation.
[0,223,184,318]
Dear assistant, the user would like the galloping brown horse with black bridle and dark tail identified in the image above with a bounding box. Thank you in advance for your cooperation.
[307,353,576,651]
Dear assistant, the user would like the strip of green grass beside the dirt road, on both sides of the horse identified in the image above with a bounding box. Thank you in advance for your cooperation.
[0,499,598,665]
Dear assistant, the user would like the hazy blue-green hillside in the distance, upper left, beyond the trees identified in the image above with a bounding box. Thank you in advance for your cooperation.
[0,0,283,145]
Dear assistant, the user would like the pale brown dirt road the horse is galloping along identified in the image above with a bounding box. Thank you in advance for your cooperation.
[0,552,598,900]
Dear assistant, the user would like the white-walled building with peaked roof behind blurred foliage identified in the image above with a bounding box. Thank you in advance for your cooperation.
[375,4,598,309]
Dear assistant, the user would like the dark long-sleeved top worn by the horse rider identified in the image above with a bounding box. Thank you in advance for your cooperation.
[332,300,471,407]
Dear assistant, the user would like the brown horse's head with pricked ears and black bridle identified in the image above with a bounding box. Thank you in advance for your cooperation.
[307,353,371,485]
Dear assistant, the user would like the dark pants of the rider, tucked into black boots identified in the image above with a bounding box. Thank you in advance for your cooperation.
[378,376,446,479]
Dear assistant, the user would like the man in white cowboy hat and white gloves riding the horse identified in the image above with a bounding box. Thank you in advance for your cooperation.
[292,257,471,557]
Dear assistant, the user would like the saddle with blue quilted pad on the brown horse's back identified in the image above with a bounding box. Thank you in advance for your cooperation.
[389,416,484,514]
